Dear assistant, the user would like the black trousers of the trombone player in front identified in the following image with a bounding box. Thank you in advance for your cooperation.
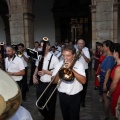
[59,92,80,120]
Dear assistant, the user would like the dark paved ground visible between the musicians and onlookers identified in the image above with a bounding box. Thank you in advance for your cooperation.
[22,68,114,120]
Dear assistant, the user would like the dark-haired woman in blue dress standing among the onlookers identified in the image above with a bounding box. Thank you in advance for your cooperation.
[100,40,115,120]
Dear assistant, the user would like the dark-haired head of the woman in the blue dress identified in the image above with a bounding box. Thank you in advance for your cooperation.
[103,40,114,53]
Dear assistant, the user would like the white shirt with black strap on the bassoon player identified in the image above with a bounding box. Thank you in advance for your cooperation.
[36,52,59,82]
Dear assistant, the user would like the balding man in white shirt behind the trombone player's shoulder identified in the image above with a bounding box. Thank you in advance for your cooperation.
[77,39,90,107]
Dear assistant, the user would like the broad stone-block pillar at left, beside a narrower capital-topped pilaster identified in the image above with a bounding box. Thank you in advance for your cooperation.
[9,0,25,44]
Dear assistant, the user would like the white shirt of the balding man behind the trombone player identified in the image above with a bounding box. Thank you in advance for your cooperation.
[79,47,90,69]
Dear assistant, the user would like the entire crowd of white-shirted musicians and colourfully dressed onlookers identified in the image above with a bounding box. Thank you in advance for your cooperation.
[0,38,120,120]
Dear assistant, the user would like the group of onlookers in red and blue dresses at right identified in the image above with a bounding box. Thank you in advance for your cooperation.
[91,40,120,120]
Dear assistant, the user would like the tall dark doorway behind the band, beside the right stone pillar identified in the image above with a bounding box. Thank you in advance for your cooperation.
[53,0,92,47]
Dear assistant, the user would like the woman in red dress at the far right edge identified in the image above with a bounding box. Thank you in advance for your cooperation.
[107,44,120,116]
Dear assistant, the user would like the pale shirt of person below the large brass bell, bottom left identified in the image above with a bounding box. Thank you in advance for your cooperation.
[10,106,33,120]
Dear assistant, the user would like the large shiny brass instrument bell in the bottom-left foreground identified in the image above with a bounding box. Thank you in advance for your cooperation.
[0,69,21,120]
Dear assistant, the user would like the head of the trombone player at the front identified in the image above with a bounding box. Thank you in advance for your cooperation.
[62,45,76,62]
